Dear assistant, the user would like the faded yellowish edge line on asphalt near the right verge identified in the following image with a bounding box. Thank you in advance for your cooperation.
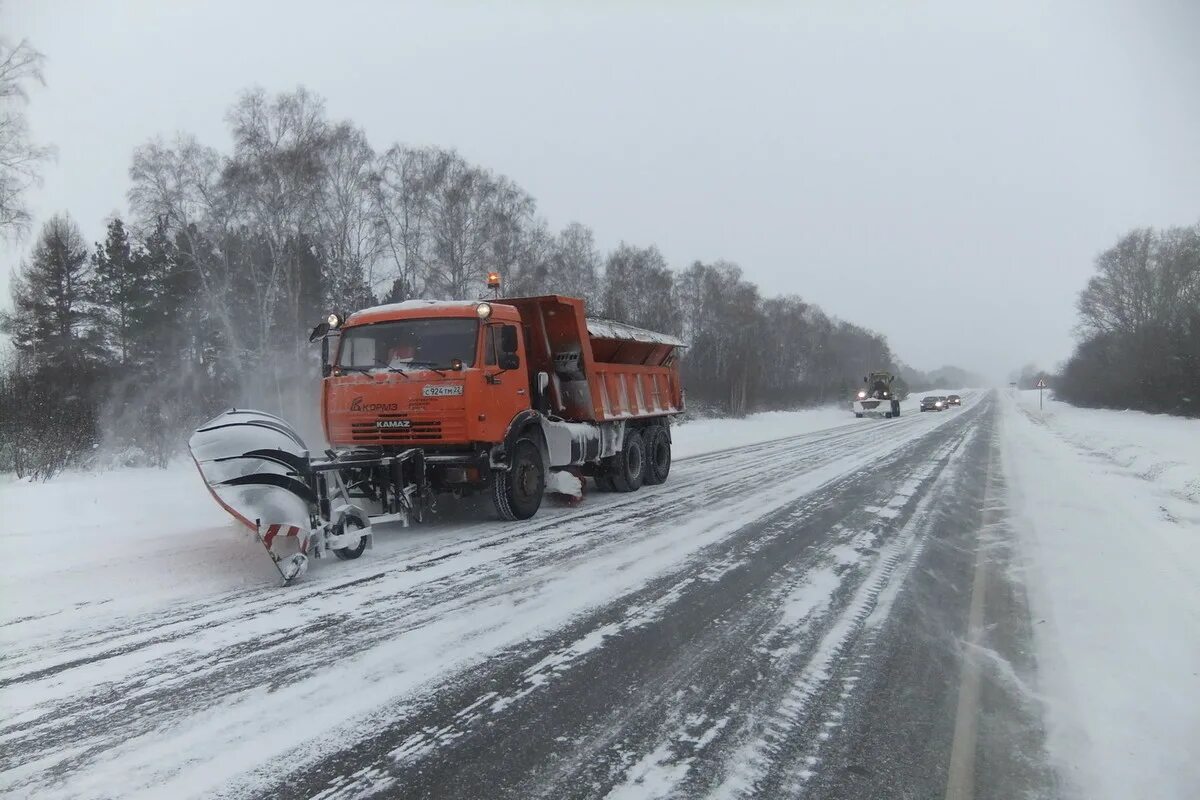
[946,438,1000,800]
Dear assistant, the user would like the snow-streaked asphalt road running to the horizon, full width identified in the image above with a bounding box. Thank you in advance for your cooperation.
[0,392,1195,798]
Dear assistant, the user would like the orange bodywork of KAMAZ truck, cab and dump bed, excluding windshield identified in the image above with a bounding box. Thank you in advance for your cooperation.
[322,295,683,450]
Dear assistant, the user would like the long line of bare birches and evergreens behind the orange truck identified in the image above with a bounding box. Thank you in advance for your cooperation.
[0,89,912,475]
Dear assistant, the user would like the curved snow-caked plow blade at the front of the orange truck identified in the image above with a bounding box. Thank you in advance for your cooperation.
[187,409,317,583]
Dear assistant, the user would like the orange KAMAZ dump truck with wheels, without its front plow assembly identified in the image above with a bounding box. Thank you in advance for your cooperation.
[324,295,683,519]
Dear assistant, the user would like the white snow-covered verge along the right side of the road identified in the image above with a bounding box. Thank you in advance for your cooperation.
[1002,391,1200,800]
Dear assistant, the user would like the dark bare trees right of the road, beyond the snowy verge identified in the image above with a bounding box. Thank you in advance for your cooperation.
[1052,224,1200,416]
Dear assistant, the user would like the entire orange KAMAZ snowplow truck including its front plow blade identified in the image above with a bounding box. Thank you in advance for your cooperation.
[190,295,683,579]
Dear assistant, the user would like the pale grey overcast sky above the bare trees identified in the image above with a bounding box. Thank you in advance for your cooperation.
[0,0,1200,379]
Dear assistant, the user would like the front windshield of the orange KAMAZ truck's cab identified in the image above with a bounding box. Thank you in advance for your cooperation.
[337,318,479,369]
